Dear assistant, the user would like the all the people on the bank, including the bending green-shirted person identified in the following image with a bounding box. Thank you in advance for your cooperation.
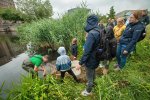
[23,11,149,96]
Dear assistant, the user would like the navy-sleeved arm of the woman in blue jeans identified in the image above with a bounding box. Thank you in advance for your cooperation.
[125,26,144,52]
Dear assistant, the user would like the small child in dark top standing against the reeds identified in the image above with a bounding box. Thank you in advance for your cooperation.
[71,38,78,60]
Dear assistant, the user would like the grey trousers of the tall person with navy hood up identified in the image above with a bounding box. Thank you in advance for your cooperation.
[86,67,95,92]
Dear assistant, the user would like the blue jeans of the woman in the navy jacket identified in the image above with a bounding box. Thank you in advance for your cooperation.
[116,44,127,69]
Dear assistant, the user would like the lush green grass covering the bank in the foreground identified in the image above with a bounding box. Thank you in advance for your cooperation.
[3,26,150,100]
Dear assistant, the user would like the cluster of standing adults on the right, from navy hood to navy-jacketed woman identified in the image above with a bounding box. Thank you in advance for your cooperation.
[76,11,149,96]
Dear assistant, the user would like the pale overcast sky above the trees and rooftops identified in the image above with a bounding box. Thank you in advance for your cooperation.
[50,0,150,18]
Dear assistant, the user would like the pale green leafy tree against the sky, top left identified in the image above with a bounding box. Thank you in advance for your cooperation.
[16,0,53,21]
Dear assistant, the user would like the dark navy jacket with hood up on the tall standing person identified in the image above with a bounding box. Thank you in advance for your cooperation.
[79,15,100,69]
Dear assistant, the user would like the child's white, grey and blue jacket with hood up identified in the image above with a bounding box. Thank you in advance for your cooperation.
[56,47,71,71]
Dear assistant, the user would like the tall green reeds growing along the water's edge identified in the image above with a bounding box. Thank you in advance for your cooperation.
[18,7,89,53]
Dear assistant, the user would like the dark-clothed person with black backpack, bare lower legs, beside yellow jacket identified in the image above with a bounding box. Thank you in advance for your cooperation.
[97,20,117,75]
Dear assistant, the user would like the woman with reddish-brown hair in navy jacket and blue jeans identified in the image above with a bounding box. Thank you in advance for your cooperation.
[115,11,145,70]
